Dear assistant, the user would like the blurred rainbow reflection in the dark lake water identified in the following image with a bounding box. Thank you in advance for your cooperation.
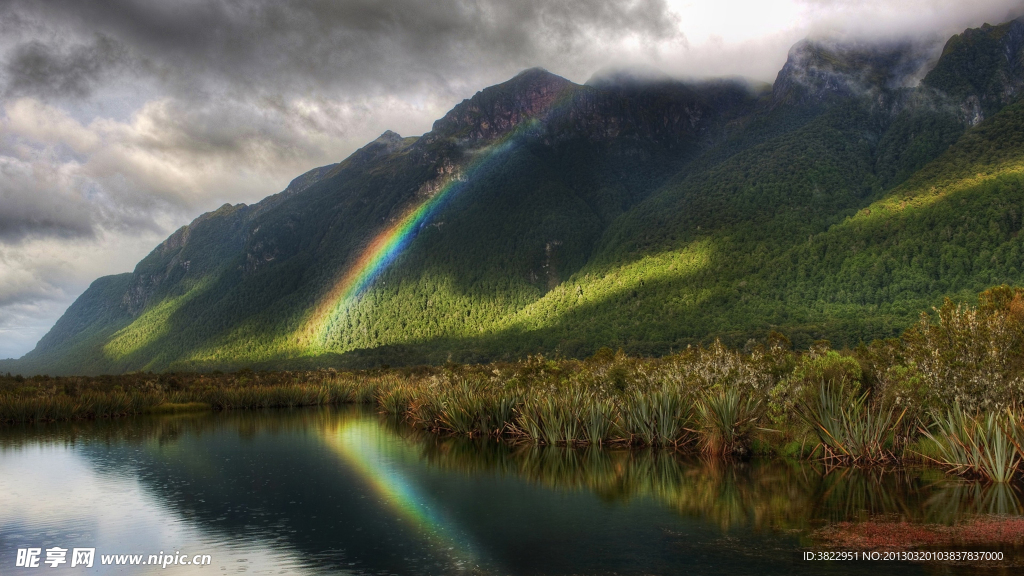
[322,418,479,568]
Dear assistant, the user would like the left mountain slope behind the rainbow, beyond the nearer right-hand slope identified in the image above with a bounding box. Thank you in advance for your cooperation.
[4,70,756,372]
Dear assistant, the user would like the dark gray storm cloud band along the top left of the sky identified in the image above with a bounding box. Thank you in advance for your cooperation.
[0,0,679,97]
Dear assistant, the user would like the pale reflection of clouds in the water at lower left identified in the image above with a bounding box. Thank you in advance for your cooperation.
[0,446,311,575]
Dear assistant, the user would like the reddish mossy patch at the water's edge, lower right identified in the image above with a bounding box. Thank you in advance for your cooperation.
[811,517,1024,550]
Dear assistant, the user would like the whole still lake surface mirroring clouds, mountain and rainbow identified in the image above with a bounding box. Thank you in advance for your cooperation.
[0,407,1024,576]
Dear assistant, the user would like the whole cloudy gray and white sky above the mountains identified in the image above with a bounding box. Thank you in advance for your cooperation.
[0,0,1024,358]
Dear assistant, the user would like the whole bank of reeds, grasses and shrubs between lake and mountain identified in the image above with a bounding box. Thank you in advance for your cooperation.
[6,287,1024,483]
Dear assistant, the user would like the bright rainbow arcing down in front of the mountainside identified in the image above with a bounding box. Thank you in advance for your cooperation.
[297,83,572,352]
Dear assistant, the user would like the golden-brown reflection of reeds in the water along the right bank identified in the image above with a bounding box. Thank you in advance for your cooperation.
[392,425,1024,530]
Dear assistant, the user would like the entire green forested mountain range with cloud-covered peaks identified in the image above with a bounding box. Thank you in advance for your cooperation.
[6,20,1024,374]
